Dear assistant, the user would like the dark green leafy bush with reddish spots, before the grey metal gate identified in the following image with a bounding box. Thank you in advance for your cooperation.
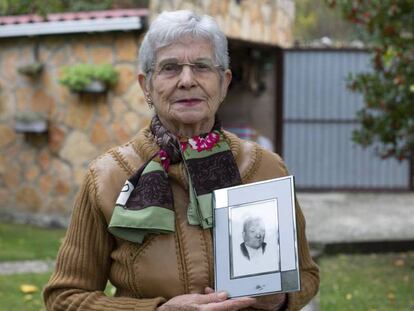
[326,0,414,160]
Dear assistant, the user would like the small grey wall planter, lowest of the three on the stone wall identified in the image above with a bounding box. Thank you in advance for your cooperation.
[14,111,48,133]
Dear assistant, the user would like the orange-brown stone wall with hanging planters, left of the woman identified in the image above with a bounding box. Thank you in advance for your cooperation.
[0,32,151,215]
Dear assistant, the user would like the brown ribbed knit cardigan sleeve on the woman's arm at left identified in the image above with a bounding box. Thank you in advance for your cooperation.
[43,170,165,311]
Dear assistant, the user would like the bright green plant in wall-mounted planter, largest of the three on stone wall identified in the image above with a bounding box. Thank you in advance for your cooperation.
[59,64,118,93]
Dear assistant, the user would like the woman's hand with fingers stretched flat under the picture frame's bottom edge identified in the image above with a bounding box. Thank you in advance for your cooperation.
[157,288,256,311]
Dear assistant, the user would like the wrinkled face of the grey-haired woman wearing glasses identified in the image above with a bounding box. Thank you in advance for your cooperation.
[141,38,231,129]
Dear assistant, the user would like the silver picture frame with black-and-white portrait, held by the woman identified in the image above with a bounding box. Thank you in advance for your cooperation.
[213,176,300,297]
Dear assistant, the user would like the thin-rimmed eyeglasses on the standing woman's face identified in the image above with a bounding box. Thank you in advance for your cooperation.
[155,60,223,78]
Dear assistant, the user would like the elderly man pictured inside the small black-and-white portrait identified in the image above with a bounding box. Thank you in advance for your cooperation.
[240,217,266,260]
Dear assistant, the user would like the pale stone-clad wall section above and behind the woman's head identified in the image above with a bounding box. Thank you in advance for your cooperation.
[150,0,295,47]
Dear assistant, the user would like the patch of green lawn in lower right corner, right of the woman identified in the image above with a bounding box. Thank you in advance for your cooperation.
[319,252,414,311]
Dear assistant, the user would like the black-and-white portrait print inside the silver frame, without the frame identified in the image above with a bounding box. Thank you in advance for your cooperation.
[229,200,280,278]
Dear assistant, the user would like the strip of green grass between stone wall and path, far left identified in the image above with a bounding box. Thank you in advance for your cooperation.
[0,223,65,261]
